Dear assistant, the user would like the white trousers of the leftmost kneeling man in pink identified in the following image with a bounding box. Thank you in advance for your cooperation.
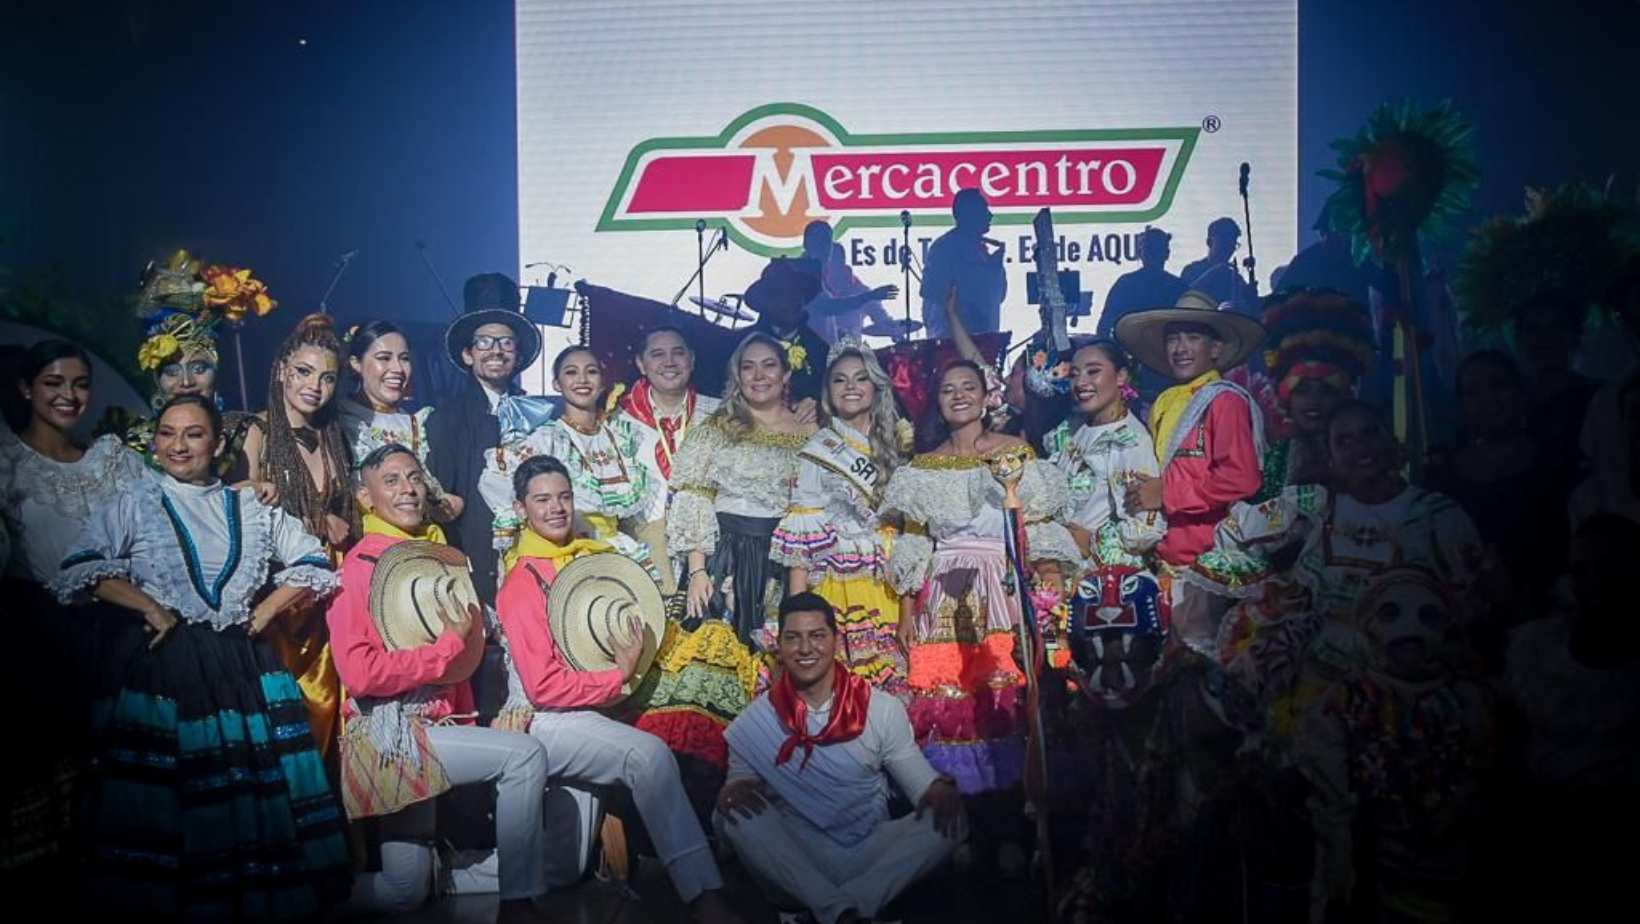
[353,725,548,914]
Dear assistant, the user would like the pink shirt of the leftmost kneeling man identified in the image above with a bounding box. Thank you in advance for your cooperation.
[325,533,474,722]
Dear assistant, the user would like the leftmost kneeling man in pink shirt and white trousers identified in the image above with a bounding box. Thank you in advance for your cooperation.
[326,443,548,921]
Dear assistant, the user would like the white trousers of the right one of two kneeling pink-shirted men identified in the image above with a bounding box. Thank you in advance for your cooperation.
[530,711,723,903]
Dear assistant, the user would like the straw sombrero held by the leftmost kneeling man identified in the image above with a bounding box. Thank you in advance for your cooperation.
[369,540,484,683]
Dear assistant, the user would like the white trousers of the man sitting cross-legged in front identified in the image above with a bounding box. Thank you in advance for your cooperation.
[712,803,958,924]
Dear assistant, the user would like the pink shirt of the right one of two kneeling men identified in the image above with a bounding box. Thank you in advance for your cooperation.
[495,551,626,709]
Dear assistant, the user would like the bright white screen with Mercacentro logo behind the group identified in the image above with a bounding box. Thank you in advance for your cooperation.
[517,0,1297,387]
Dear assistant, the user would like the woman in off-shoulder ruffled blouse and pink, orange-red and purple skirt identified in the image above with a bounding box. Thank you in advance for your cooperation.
[882,361,1081,793]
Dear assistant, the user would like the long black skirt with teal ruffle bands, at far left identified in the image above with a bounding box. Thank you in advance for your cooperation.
[85,619,349,921]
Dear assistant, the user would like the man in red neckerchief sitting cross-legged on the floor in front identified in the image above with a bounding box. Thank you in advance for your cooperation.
[715,592,968,924]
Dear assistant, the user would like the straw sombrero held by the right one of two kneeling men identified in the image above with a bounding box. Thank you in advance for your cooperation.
[546,551,666,698]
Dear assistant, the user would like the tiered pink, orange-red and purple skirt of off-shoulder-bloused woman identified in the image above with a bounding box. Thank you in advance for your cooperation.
[909,538,1025,793]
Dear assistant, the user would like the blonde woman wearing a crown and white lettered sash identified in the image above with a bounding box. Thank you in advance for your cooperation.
[771,336,910,699]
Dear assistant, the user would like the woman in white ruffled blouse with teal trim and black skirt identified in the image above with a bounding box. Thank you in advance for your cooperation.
[51,396,349,919]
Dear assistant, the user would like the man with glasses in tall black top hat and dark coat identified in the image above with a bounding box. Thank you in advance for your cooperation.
[426,272,546,602]
